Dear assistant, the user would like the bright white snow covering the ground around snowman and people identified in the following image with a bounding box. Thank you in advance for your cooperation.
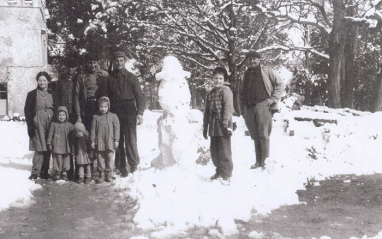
[0,103,382,238]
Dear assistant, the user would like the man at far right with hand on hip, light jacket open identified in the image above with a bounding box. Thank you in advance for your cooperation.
[239,51,285,169]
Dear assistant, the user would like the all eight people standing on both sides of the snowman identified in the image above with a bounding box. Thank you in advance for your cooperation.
[25,51,285,186]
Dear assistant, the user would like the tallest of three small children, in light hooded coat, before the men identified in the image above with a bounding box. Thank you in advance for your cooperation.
[90,96,120,184]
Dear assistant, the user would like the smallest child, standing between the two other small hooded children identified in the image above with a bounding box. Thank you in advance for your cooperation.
[72,122,92,184]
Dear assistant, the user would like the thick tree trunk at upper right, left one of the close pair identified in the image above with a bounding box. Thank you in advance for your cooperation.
[328,0,346,108]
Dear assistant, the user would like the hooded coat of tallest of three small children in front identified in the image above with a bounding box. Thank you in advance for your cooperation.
[90,97,120,151]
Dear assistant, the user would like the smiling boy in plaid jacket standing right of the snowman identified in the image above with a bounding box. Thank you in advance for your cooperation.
[203,67,234,185]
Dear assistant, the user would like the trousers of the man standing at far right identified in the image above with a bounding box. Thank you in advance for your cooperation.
[244,101,272,165]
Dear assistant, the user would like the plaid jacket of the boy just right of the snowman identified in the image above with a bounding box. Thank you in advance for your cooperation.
[203,85,234,136]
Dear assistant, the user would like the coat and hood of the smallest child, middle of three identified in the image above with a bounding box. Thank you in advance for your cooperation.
[71,123,91,165]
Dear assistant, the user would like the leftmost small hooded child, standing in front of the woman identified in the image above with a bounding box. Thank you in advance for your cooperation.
[47,106,73,181]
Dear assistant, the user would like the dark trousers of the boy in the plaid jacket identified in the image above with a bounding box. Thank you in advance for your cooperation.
[210,136,233,177]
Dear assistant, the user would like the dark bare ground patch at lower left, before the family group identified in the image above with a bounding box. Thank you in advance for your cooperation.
[0,180,137,239]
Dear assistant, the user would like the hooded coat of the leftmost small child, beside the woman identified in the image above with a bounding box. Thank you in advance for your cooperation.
[47,106,73,154]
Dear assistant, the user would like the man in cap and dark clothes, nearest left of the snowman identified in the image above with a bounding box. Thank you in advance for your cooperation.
[107,51,145,177]
